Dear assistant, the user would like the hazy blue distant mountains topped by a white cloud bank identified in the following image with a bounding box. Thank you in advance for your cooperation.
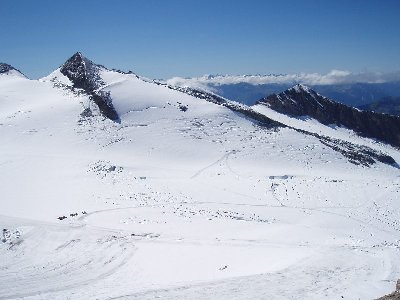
[167,71,400,107]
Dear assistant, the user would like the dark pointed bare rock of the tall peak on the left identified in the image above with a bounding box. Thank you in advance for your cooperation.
[60,52,119,121]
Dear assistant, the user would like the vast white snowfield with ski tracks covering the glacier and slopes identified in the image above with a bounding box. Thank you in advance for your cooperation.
[0,66,400,299]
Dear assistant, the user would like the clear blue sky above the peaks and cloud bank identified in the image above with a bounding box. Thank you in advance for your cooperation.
[0,0,400,78]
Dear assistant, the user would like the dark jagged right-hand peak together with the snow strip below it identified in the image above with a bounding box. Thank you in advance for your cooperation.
[252,85,400,161]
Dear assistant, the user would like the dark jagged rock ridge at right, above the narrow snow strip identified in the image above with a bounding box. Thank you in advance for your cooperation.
[257,84,400,147]
